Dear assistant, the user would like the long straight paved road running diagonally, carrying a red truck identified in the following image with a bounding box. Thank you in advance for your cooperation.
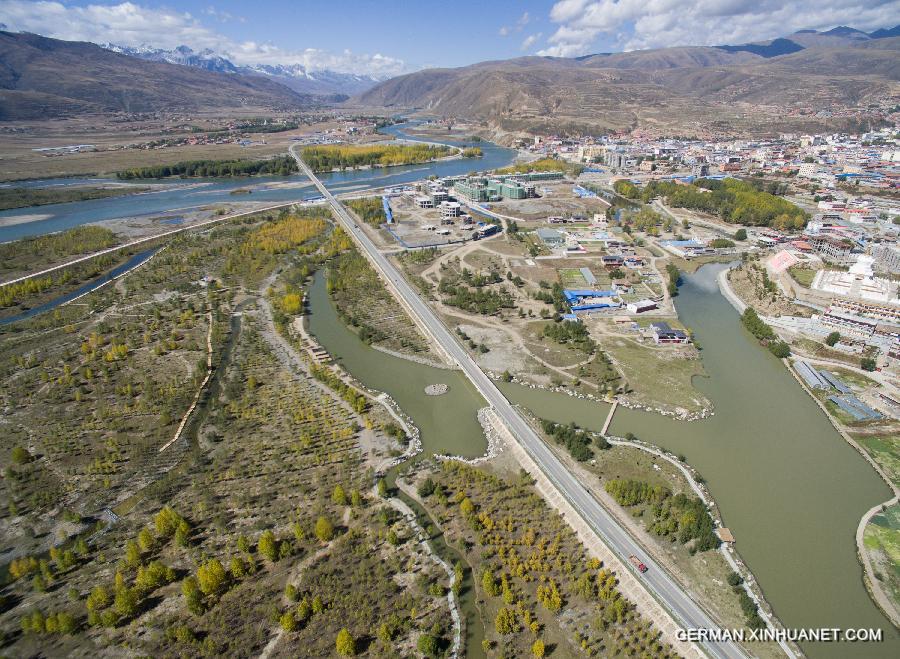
[291,147,747,657]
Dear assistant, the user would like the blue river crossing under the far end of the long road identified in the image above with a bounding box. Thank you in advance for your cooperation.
[0,122,516,243]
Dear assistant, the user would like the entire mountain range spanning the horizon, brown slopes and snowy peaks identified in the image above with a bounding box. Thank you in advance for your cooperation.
[0,26,900,139]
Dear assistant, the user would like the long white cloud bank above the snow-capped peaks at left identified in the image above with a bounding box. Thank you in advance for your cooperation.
[0,0,406,76]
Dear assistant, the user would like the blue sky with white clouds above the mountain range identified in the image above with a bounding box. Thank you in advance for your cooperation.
[0,0,900,77]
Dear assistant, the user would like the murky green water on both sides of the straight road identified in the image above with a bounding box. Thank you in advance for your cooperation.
[310,265,900,658]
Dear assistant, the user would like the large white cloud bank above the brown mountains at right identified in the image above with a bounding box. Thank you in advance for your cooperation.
[538,0,900,57]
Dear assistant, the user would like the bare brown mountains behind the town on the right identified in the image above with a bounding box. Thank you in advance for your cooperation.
[351,26,900,137]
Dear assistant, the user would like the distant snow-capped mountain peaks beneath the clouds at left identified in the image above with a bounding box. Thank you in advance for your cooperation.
[102,43,385,95]
